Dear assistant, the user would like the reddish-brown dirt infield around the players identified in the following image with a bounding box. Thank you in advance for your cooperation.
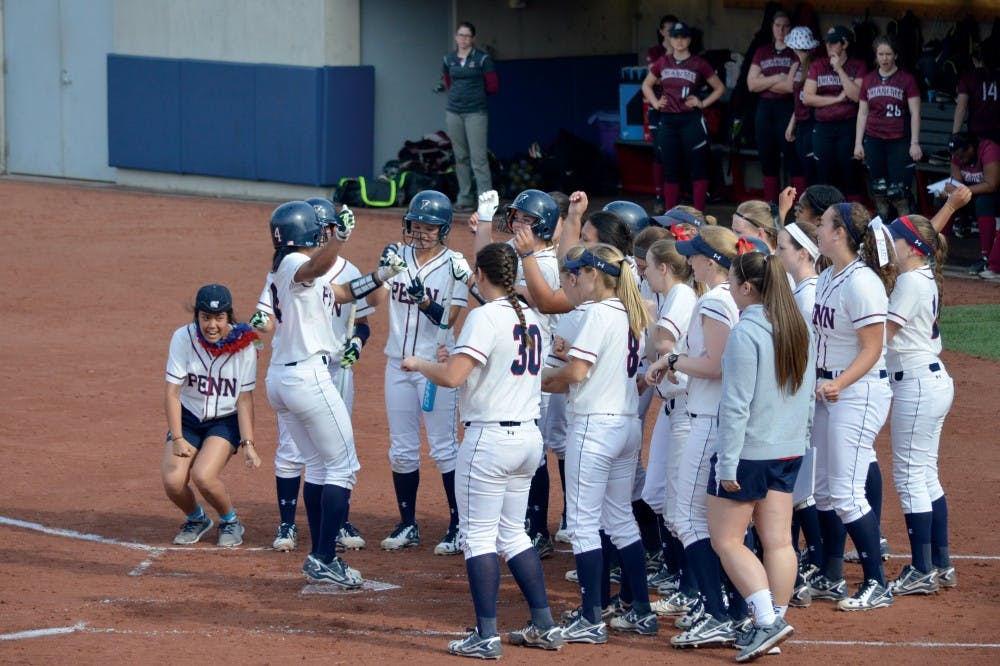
[0,180,1000,665]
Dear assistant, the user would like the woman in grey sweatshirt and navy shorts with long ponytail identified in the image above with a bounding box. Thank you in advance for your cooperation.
[708,252,813,662]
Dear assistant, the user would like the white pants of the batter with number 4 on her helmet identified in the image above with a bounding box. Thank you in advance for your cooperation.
[265,355,361,490]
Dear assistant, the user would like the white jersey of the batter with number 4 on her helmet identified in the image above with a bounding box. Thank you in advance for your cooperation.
[271,252,343,365]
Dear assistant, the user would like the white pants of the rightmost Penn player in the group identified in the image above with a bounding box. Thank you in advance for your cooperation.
[890,363,955,513]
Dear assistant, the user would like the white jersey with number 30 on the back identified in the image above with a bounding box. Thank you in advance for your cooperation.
[452,298,544,423]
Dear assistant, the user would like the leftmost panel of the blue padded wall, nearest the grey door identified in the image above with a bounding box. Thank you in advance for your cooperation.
[108,55,181,172]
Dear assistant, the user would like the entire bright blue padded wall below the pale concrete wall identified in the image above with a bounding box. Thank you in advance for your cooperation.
[108,55,375,186]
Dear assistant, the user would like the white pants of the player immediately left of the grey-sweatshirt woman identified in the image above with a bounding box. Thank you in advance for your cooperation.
[668,414,719,548]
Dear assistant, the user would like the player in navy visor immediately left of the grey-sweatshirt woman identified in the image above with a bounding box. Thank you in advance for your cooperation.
[647,222,739,648]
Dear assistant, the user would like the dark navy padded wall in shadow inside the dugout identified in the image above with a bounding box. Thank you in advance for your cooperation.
[489,53,636,159]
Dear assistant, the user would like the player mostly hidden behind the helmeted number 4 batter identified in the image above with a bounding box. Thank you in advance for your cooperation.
[257,206,375,551]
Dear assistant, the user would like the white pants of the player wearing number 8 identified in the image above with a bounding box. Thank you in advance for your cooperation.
[566,414,642,555]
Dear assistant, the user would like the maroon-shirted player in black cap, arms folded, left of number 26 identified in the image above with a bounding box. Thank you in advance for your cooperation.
[802,25,867,201]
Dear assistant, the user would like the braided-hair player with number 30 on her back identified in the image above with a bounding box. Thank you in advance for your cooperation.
[402,243,563,659]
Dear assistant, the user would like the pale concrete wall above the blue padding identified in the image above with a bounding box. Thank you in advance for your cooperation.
[115,0,361,67]
